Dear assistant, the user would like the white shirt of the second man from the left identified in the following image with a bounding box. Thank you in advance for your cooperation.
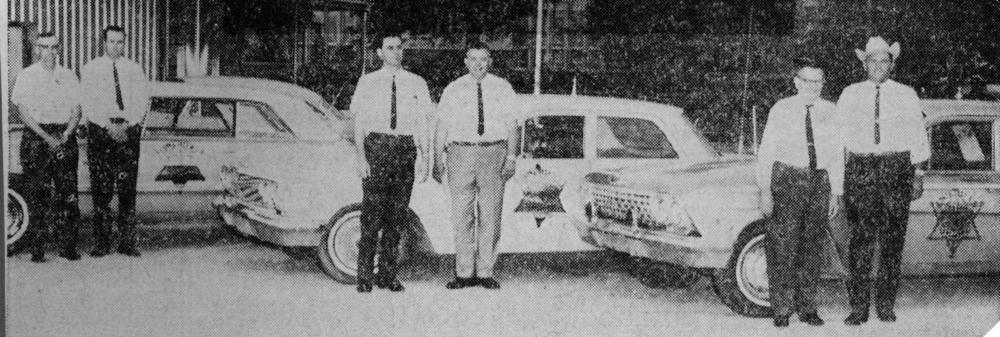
[80,56,149,127]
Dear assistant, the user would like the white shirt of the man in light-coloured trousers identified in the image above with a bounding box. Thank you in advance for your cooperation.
[438,74,523,143]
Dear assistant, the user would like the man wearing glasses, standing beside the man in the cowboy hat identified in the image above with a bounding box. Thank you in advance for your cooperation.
[757,59,843,327]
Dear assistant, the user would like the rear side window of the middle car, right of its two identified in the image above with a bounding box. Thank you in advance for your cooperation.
[594,116,677,159]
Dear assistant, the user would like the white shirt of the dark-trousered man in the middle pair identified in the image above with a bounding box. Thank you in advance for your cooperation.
[351,68,433,137]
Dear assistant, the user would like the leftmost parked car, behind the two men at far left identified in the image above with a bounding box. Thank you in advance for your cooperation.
[6,79,344,245]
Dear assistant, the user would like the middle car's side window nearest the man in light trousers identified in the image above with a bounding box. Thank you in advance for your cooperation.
[524,116,584,159]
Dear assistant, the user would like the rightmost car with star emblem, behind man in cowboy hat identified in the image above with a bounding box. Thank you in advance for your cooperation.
[579,100,1000,316]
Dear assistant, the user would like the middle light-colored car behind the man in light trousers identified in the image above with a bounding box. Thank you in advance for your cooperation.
[216,95,717,283]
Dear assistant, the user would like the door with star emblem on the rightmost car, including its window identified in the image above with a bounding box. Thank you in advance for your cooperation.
[903,117,1000,274]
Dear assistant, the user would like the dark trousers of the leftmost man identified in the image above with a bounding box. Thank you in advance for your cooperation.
[20,124,80,254]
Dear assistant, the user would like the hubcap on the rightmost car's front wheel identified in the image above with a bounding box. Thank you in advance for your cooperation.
[736,235,771,307]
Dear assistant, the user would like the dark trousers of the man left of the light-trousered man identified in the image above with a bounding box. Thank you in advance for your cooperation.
[358,133,417,282]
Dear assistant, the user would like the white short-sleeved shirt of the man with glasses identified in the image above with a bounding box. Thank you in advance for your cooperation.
[757,95,844,195]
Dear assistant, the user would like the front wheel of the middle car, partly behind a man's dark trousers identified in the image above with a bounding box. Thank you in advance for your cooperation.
[316,204,419,284]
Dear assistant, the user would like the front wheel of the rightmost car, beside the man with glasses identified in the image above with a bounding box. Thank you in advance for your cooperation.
[712,222,773,317]
